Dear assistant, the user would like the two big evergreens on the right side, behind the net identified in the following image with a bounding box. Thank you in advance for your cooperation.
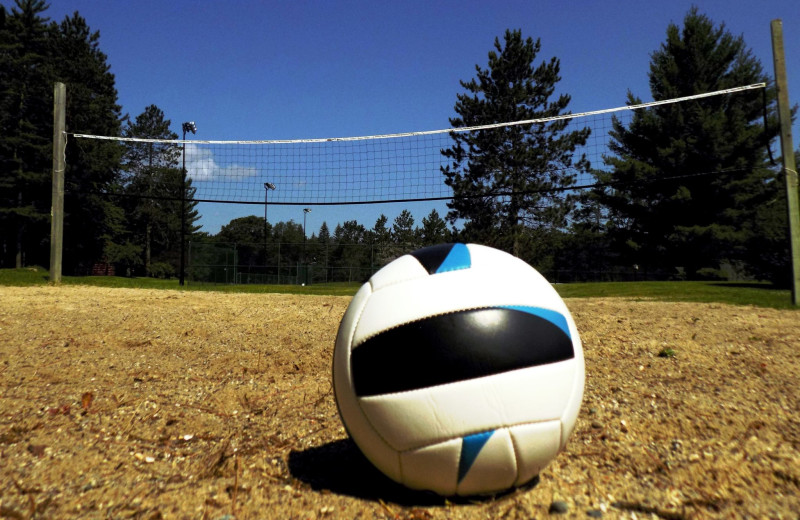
[442,13,797,285]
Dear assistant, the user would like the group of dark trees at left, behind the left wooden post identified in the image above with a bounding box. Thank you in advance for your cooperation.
[0,0,199,275]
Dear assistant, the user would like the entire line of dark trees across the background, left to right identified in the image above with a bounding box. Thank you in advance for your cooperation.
[0,0,796,283]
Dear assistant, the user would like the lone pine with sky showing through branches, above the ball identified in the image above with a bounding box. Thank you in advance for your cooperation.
[442,30,589,256]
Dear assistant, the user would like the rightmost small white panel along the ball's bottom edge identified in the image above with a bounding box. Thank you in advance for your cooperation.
[509,421,562,486]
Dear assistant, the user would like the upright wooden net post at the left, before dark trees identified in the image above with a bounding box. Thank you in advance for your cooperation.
[50,83,67,284]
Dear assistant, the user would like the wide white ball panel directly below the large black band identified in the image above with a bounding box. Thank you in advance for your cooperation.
[360,359,576,450]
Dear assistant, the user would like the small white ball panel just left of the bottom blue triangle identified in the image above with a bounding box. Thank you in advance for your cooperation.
[397,438,461,495]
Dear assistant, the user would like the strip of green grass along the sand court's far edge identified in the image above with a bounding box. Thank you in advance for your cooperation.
[0,267,796,309]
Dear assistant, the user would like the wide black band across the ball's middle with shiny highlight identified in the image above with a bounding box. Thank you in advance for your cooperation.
[351,308,575,396]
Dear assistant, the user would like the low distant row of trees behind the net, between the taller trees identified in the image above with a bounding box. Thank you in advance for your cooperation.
[189,209,457,283]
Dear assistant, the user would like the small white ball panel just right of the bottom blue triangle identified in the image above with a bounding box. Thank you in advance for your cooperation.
[457,429,517,495]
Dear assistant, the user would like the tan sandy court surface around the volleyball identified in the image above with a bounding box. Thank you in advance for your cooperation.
[0,286,800,520]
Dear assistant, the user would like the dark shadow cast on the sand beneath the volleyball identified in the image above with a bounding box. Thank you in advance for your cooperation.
[288,438,539,507]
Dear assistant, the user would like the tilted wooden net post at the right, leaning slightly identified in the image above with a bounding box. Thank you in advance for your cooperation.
[771,19,800,306]
